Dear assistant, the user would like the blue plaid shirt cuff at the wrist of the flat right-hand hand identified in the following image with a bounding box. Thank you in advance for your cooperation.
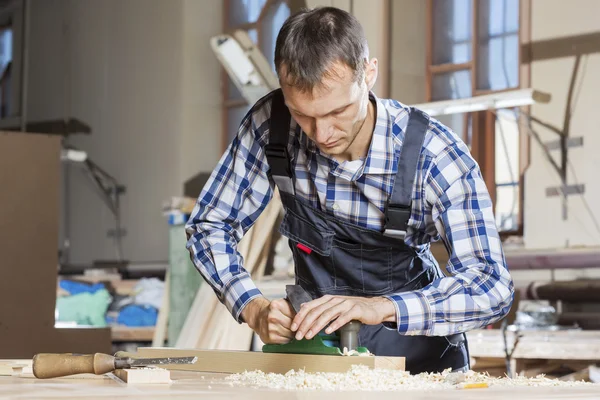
[384,291,433,335]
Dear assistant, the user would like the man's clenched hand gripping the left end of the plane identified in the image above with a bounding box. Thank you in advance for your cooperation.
[242,297,295,344]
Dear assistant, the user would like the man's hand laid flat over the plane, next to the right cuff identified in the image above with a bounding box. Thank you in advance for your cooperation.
[291,295,396,340]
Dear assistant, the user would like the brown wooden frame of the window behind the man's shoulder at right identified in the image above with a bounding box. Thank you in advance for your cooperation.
[425,0,531,239]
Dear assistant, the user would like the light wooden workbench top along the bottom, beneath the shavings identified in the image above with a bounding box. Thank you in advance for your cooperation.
[0,371,600,400]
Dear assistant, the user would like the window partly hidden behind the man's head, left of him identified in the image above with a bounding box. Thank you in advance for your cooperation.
[221,0,290,149]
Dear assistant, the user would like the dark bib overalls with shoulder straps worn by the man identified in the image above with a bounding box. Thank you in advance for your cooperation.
[266,90,469,374]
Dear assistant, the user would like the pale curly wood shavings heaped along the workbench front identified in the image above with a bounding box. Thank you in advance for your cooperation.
[225,365,593,391]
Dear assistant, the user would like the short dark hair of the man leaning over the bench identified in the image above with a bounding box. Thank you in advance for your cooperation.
[275,7,368,91]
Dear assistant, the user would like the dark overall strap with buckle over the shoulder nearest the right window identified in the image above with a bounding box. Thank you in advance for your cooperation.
[383,108,429,239]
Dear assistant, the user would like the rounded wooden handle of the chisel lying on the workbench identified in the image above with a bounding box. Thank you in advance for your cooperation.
[33,353,115,379]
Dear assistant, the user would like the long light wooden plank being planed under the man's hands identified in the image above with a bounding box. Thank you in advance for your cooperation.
[136,347,405,374]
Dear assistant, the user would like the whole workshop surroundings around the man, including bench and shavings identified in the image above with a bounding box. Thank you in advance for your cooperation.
[0,0,600,399]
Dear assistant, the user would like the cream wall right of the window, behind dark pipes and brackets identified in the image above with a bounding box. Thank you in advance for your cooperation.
[524,0,600,248]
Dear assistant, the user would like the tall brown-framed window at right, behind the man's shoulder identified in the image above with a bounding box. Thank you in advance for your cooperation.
[426,0,528,234]
